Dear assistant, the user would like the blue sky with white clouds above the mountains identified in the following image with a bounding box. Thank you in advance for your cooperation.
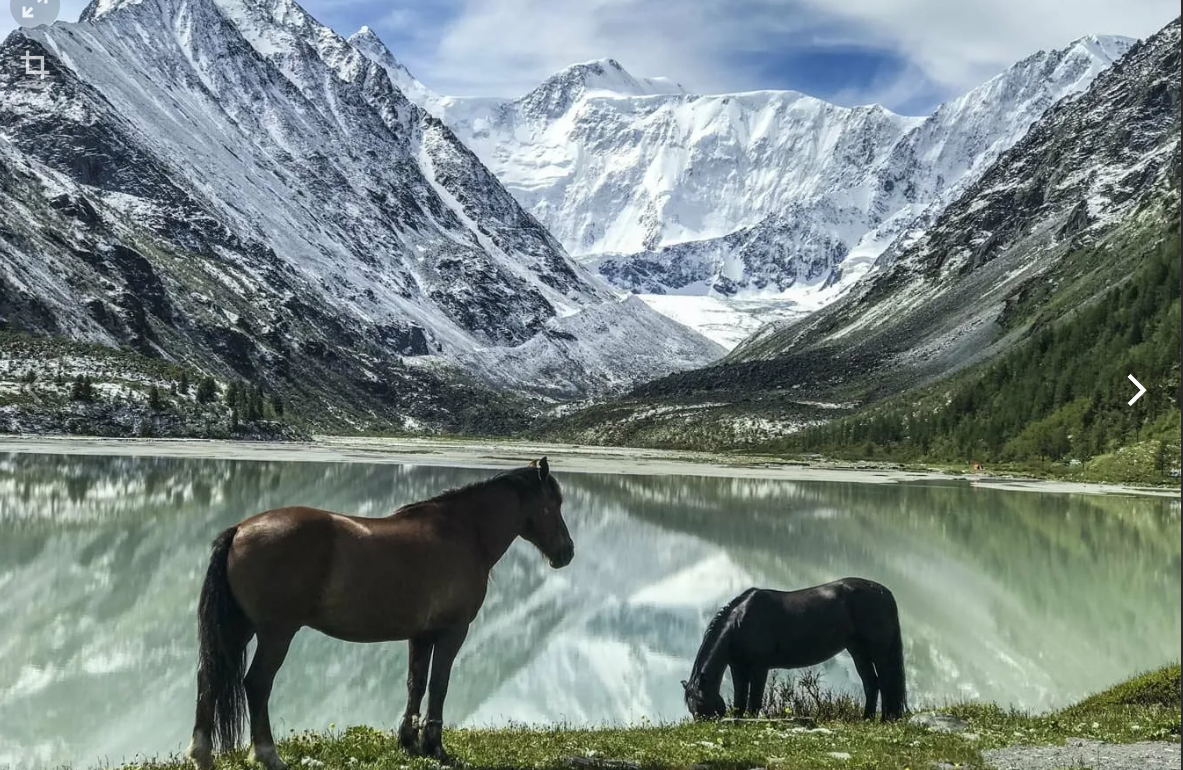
[0,0,1179,115]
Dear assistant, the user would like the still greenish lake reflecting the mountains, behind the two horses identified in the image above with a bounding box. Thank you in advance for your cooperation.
[0,454,1181,770]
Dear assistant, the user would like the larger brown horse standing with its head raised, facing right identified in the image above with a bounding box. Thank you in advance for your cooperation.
[187,458,575,770]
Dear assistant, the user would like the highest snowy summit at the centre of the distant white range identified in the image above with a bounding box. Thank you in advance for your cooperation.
[518,59,686,119]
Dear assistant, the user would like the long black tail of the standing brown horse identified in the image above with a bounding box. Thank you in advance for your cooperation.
[198,526,250,751]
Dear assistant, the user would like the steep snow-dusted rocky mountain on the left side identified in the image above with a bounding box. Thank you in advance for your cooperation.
[0,0,722,428]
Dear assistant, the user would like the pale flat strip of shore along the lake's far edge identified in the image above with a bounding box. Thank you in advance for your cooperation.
[0,434,1179,498]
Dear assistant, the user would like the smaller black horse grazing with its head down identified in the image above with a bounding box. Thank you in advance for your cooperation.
[681,577,907,720]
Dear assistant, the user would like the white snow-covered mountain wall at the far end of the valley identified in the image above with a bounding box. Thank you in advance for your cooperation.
[354,28,1132,345]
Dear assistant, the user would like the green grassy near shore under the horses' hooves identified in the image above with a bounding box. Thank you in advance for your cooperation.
[123,665,1181,770]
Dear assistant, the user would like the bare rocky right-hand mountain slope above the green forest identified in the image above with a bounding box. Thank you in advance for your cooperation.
[541,21,1179,442]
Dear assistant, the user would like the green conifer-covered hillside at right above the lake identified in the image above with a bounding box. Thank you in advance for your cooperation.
[768,233,1181,480]
